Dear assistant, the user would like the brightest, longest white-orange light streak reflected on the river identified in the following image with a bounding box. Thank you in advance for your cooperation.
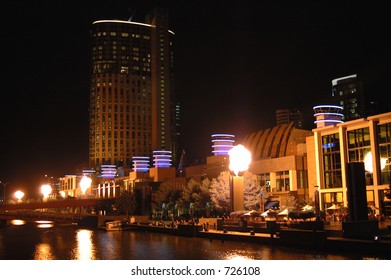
[74,229,96,260]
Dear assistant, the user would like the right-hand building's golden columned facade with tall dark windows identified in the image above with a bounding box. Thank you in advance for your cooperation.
[306,113,391,215]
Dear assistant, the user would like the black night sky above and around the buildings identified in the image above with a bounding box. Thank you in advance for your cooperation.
[0,0,391,197]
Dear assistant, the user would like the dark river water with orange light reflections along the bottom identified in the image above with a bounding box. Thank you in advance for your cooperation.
[0,221,382,260]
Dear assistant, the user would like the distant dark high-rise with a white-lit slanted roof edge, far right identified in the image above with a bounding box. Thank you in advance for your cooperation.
[331,74,368,121]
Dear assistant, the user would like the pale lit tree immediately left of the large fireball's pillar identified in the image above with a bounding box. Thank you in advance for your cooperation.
[210,171,231,213]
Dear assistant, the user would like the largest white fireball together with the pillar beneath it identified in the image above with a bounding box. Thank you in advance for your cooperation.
[228,145,251,212]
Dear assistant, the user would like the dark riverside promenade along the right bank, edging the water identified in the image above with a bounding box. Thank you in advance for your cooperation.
[124,220,391,259]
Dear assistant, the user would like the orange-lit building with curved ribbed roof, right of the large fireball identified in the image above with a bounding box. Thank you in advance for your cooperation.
[242,122,312,206]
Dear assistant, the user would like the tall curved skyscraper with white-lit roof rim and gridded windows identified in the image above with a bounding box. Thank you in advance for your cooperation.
[89,8,179,169]
